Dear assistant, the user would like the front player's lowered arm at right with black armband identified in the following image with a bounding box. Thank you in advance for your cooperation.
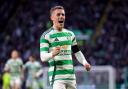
[71,34,91,71]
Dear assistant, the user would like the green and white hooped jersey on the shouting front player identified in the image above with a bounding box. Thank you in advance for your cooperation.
[40,27,77,84]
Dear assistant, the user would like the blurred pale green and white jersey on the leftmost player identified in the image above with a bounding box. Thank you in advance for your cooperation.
[5,58,23,77]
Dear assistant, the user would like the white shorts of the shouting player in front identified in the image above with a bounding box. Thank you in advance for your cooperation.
[53,80,77,89]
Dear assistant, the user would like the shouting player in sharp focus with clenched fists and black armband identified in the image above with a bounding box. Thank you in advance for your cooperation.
[40,6,91,89]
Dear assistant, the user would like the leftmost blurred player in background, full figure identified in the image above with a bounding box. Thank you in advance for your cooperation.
[4,50,23,89]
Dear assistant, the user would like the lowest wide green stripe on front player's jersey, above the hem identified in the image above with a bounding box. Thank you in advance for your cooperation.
[48,69,74,76]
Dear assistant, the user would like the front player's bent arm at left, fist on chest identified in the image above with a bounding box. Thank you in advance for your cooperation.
[40,36,60,62]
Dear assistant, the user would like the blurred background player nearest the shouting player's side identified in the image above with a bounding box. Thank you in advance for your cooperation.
[24,55,43,89]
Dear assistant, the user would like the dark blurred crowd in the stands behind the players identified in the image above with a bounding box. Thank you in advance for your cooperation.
[0,0,128,88]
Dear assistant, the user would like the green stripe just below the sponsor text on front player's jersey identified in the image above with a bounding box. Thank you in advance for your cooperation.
[49,60,73,66]
